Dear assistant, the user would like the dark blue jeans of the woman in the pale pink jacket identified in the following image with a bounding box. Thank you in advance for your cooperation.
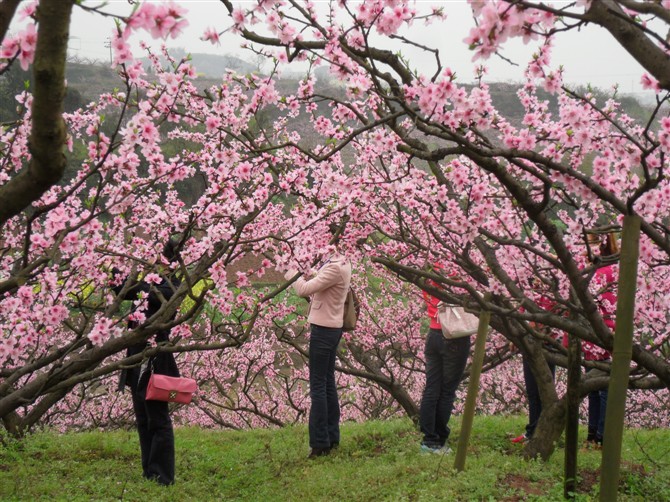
[309,324,342,448]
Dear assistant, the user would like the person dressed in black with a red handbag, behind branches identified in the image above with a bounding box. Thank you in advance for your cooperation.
[114,240,180,485]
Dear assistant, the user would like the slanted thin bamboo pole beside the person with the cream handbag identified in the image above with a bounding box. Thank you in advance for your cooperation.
[454,293,491,472]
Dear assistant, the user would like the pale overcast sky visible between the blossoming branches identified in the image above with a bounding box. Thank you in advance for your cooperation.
[64,0,650,99]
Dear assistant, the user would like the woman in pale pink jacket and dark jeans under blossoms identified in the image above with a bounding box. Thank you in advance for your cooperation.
[286,243,351,458]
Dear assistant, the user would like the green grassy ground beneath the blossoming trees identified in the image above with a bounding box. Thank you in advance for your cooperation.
[0,417,670,501]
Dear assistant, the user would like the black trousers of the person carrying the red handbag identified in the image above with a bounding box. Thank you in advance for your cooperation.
[131,377,174,485]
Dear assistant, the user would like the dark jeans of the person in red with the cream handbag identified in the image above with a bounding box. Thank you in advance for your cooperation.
[419,328,470,448]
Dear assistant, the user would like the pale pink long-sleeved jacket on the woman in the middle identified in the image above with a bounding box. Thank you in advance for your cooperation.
[285,254,351,328]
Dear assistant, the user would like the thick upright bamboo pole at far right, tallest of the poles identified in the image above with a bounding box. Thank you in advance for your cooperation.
[600,215,641,502]
